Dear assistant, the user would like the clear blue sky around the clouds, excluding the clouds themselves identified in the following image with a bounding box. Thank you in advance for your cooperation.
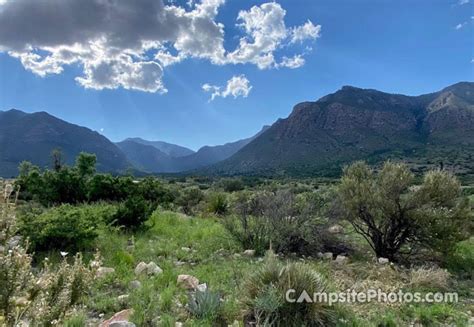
[0,0,474,149]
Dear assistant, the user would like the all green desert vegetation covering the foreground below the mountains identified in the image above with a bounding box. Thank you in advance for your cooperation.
[0,153,474,327]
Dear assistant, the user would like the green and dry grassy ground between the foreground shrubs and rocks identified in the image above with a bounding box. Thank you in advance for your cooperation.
[70,211,474,326]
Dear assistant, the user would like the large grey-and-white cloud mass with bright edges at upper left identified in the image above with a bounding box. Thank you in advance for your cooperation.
[0,0,321,93]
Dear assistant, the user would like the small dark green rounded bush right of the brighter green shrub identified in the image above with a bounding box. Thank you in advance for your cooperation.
[110,195,156,229]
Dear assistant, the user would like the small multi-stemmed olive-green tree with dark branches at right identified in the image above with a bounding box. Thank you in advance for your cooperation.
[337,162,472,261]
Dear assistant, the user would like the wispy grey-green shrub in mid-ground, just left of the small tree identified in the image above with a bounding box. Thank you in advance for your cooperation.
[224,191,323,255]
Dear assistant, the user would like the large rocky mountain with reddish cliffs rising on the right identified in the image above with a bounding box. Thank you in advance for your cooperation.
[209,82,474,178]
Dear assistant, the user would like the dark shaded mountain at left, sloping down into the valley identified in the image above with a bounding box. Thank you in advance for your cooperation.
[0,109,130,177]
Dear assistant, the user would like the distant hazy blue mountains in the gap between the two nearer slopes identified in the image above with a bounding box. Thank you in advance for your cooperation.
[116,126,268,173]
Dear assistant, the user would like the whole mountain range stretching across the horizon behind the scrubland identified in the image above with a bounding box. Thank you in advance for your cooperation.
[0,82,474,176]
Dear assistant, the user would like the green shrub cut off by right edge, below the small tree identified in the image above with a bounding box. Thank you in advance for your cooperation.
[447,237,474,279]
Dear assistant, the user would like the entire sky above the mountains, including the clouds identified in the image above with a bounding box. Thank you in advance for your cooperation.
[0,0,474,150]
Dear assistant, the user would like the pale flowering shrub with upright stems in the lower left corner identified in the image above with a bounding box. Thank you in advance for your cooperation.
[0,181,100,326]
